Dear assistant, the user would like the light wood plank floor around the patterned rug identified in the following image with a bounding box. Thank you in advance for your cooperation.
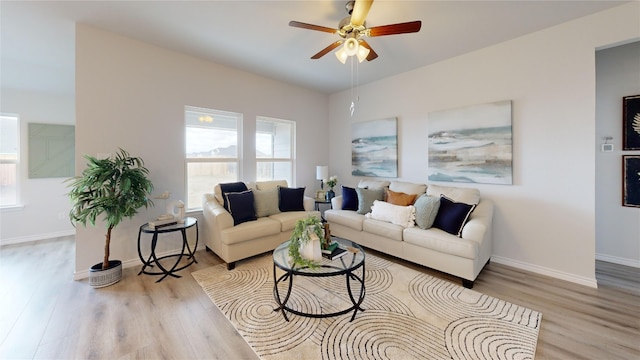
[0,237,640,359]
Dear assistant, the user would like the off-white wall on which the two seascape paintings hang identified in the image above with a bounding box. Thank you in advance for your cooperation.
[330,2,640,286]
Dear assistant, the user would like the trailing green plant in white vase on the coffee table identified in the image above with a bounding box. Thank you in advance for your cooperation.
[289,216,324,268]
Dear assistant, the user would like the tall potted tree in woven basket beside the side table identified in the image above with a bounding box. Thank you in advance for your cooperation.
[67,149,153,287]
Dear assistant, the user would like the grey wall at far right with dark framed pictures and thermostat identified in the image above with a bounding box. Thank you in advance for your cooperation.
[595,42,640,267]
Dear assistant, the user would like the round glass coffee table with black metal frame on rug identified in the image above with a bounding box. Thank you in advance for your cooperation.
[273,237,365,321]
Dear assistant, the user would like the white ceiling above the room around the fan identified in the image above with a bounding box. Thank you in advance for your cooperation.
[0,0,624,93]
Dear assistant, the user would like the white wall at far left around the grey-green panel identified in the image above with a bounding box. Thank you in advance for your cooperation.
[0,87,75,245]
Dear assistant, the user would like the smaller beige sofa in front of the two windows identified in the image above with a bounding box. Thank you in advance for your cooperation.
[202,180,320,270]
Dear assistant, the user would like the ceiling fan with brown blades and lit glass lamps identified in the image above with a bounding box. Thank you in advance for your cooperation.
[289,0,422,64]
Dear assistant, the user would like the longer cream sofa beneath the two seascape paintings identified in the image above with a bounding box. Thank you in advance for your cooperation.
[324,181,493,288]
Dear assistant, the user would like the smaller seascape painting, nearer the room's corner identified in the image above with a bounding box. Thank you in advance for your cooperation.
[351,118,398,177]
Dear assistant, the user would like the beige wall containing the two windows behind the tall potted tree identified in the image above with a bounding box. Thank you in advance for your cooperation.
[76,25,328,277]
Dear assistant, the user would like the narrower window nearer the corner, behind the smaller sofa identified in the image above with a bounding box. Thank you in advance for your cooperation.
[256,117,296,185]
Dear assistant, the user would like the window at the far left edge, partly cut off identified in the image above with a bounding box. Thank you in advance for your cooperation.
[0,115,20,207]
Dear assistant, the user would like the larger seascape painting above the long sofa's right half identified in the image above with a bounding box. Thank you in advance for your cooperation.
[428,100,513,185]
